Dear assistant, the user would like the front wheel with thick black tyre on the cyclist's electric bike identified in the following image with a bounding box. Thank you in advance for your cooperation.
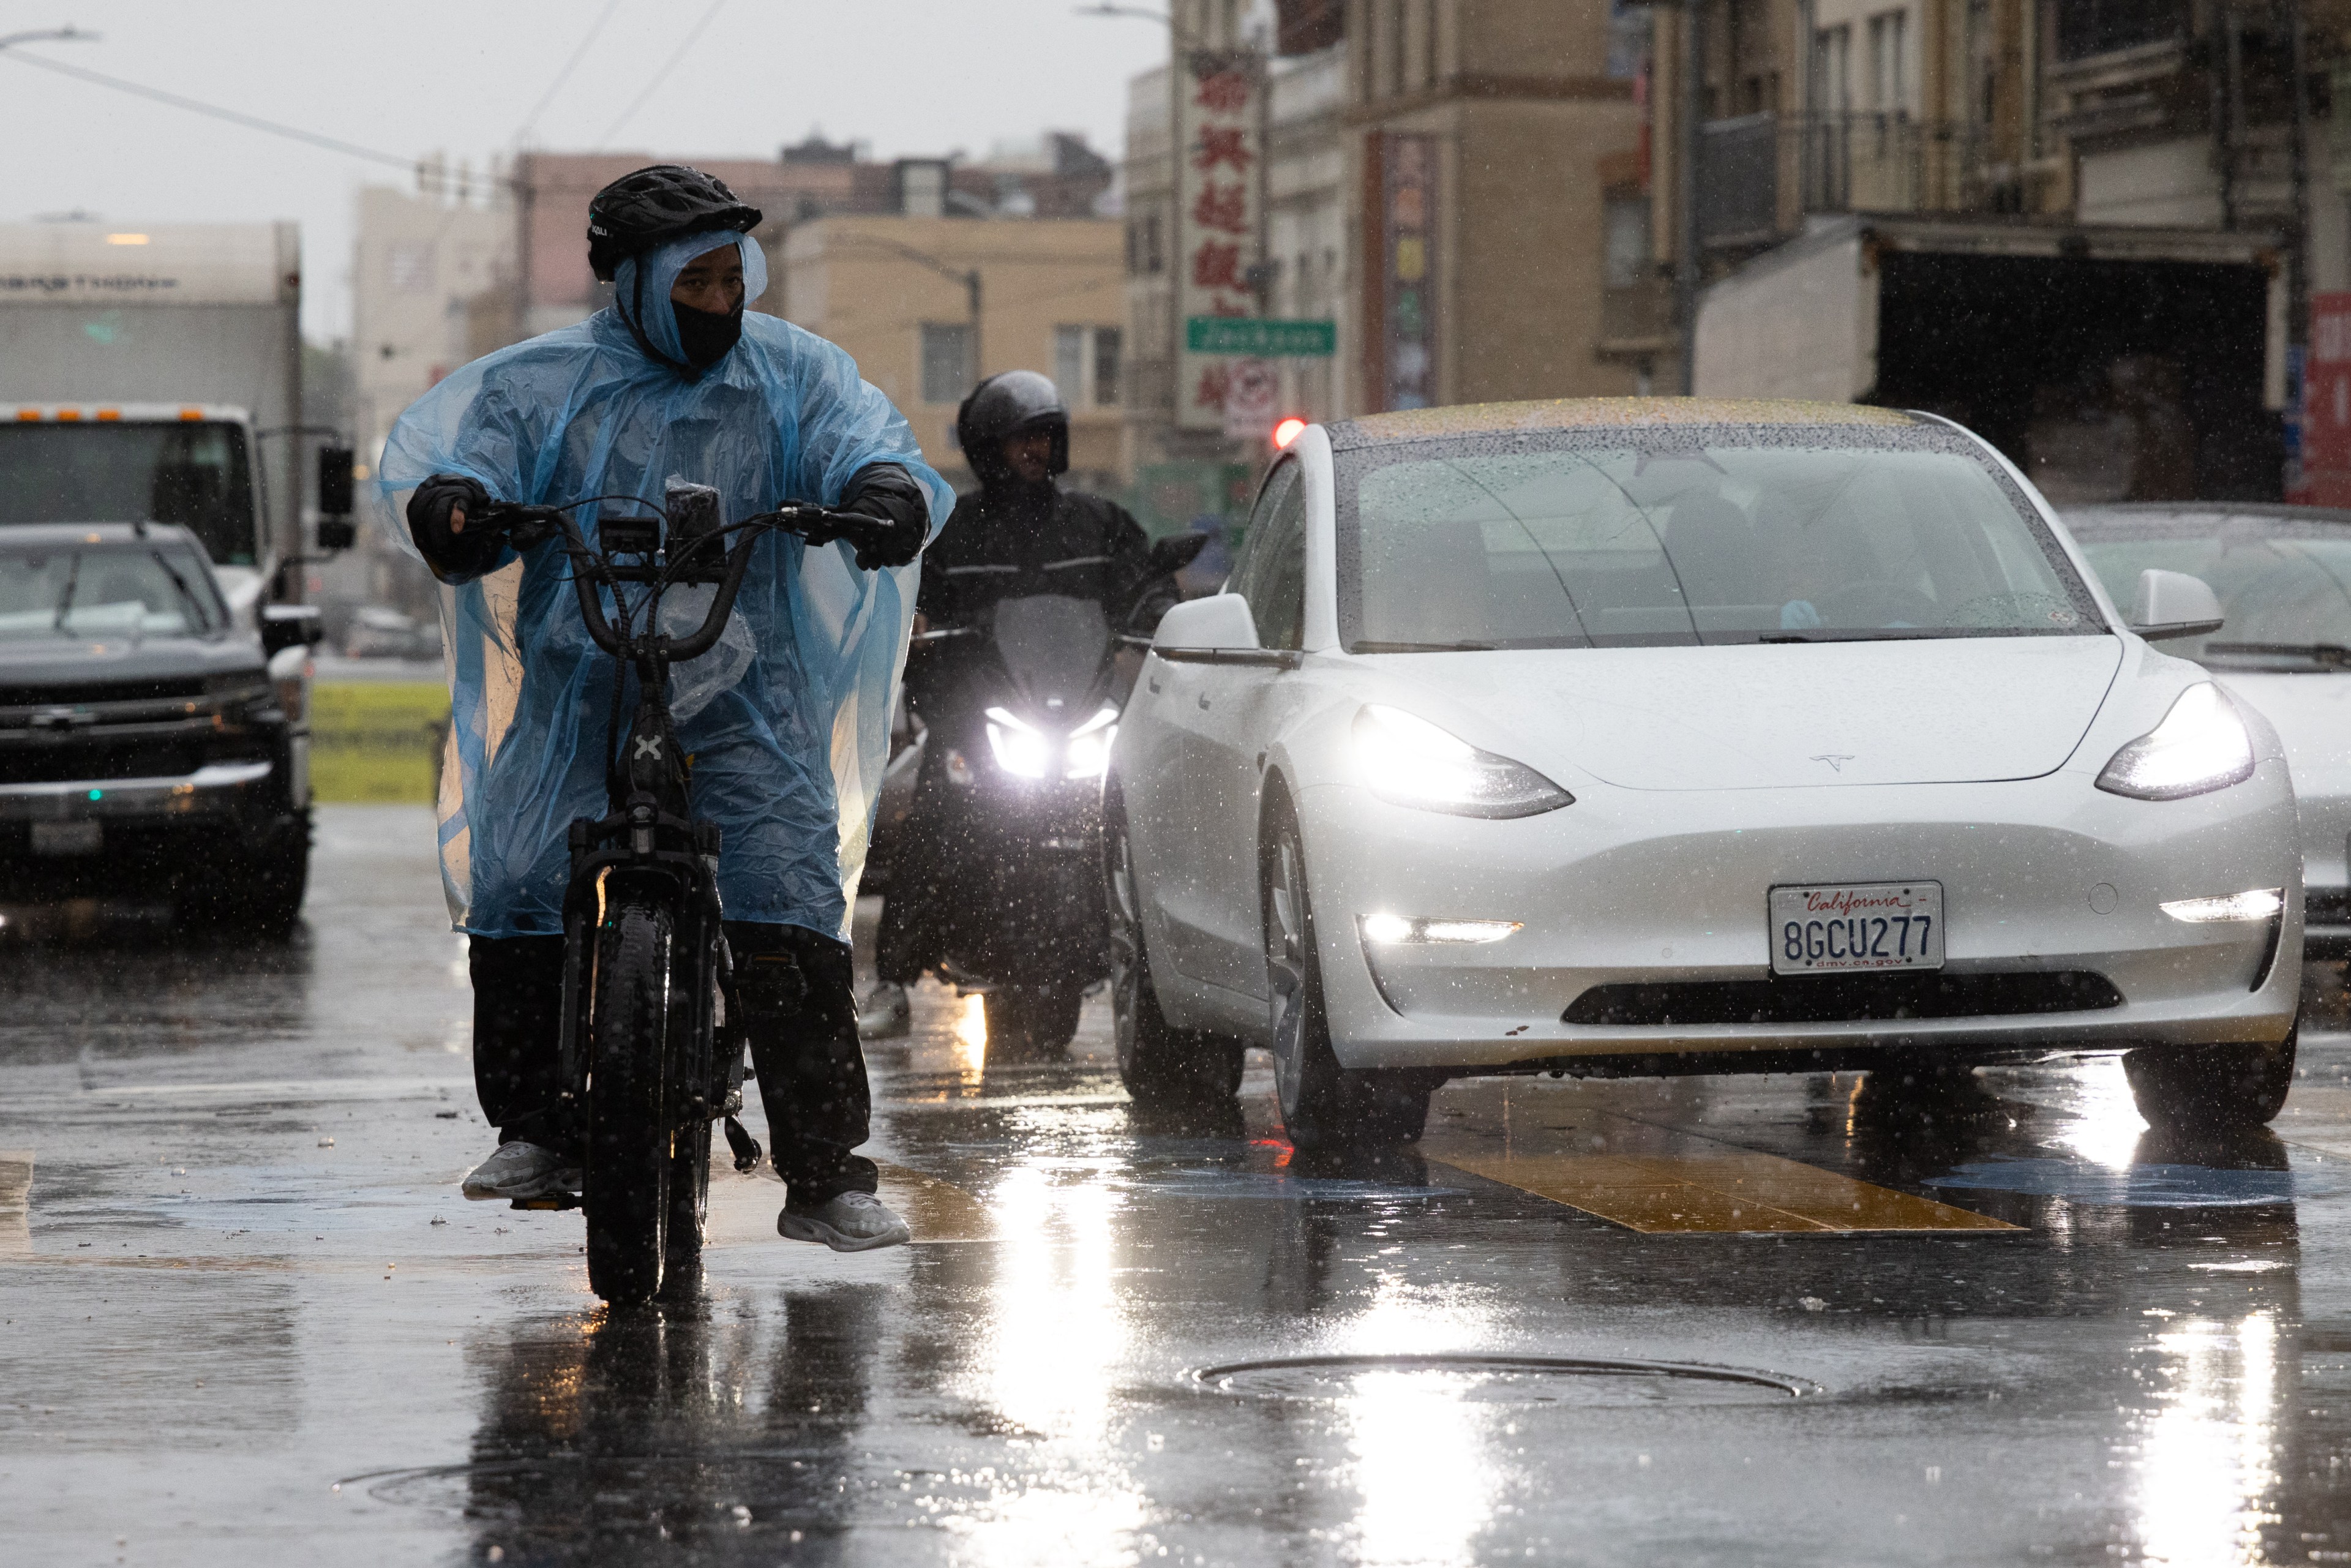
[580,898,672,1307]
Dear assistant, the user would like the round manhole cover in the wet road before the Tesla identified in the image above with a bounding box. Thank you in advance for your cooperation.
[1192,1354,1820,1406]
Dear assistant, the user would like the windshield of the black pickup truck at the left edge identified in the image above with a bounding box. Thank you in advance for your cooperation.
[0,546,228,642]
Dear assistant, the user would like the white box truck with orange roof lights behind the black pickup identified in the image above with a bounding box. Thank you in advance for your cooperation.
[0,221,322,623]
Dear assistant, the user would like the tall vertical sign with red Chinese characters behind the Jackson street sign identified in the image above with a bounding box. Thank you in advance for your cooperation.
[1173,51,1265,430]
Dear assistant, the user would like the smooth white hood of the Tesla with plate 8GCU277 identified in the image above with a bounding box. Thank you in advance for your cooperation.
[1392,637,2123,790]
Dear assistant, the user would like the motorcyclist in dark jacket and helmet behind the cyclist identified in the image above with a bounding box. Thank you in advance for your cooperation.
[858,369,1176,1039]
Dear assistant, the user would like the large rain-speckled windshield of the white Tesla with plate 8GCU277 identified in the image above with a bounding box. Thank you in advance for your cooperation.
[1338,426,2104,653]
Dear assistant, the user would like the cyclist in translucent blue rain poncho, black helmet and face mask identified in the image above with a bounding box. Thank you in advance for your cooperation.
[378,165,954,1251]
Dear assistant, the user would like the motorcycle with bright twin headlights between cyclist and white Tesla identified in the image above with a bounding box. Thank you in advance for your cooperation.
[884,534,1209,1053]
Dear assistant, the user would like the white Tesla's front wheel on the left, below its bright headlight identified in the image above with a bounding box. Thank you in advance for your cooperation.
[1260,806,1441,1150]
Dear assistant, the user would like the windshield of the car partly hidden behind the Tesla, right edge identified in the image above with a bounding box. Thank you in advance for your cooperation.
[2066,506,2351,672]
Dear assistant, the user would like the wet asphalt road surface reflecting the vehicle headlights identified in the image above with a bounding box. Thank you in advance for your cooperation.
[13,806,2351,1568]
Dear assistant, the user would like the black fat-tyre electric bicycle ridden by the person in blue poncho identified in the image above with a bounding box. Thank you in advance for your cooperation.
[482,482,887,1307]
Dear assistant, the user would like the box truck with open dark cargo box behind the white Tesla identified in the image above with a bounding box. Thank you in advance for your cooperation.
[1693,216,2285,503]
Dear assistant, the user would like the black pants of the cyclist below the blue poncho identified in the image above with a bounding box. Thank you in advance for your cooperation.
[470,919,874,1206]
